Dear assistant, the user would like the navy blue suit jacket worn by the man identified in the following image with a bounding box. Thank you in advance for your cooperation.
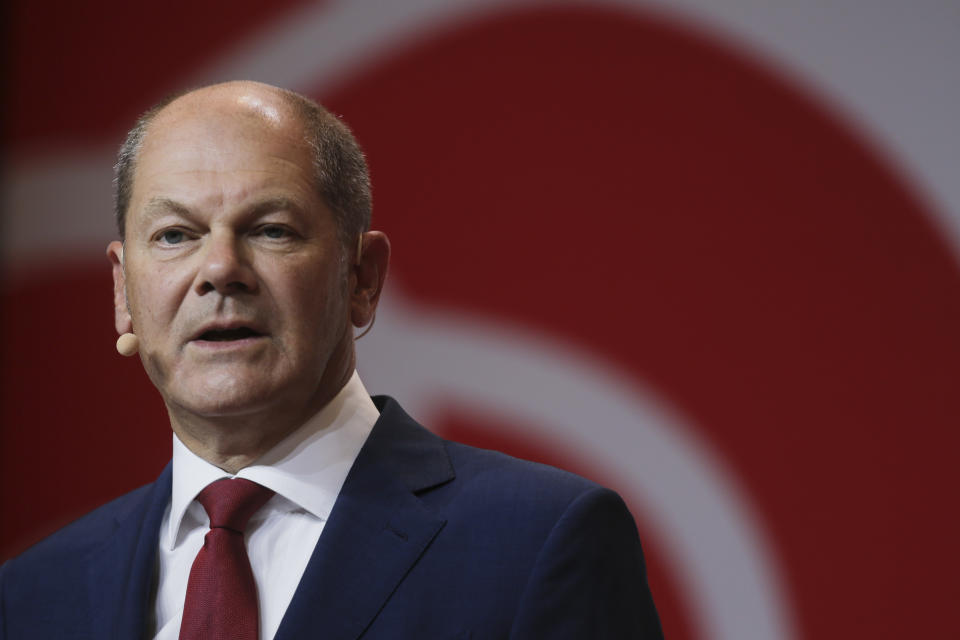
[0,397,662,640]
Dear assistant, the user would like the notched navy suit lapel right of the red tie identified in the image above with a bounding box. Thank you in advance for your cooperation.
[276,398,453,640]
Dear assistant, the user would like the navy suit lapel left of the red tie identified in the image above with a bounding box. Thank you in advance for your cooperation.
[88,464,171,638]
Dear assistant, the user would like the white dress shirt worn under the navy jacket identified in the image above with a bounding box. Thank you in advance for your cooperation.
[154,371,380,640]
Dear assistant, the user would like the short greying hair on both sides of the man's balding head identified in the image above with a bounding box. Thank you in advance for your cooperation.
[114,87,373,247]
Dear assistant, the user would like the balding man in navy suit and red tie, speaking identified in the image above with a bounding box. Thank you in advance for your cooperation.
[0,82,661,640]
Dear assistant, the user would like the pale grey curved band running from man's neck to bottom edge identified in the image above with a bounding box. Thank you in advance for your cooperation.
[357,290,794,640]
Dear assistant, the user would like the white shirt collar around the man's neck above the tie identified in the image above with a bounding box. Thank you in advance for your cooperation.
[163,371,380,550]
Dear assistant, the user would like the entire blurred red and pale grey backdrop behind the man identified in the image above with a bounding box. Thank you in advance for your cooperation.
[0,0,960,640]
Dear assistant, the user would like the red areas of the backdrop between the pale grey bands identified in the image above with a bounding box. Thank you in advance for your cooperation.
[0,0,960,638]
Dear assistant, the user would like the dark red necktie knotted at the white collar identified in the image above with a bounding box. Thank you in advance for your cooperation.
[180,478,273,640]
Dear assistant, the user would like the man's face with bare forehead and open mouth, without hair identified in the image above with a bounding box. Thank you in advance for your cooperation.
[111,89,352,418]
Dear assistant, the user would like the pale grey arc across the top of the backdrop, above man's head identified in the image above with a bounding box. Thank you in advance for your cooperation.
[196,0,960,261]
